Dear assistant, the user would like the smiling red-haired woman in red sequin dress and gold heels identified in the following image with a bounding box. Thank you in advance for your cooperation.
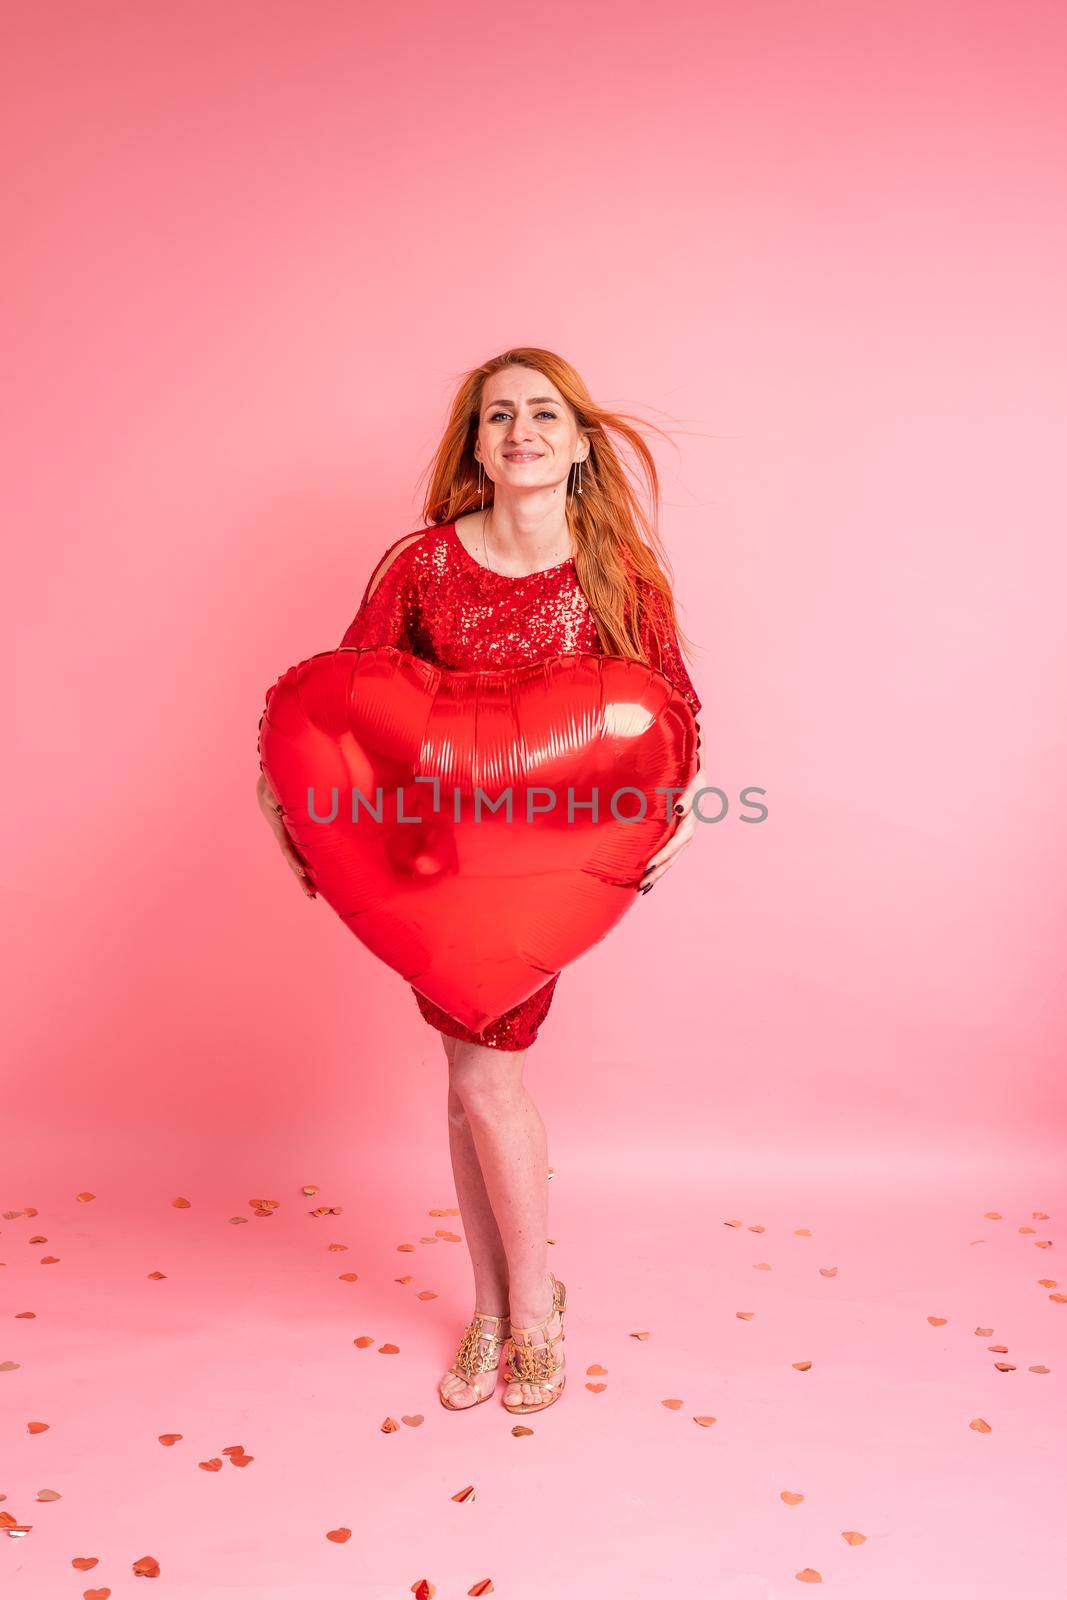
[261,349,705,1413]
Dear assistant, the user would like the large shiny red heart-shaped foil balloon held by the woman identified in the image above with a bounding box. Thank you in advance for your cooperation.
[259,645,697,1032]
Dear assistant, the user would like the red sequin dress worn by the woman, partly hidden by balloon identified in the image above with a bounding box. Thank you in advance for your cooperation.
[341,522,701,1050]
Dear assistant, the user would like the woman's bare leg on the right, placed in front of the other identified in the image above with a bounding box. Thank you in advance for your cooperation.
[450,1040,563,1405]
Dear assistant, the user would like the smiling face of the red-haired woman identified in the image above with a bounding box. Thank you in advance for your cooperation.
[475,366,589,493]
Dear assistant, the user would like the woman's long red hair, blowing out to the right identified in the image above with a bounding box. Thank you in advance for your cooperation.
[422,346,703,661]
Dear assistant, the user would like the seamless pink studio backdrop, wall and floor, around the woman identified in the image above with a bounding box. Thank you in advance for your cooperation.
[0,0,1067,1600]
